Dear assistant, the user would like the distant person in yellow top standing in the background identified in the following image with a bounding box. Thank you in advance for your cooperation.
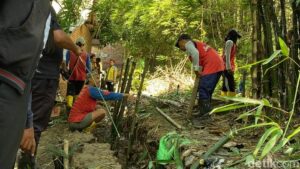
[106,59,118,92]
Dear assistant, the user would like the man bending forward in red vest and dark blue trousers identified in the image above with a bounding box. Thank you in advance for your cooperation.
[176,34,224,123]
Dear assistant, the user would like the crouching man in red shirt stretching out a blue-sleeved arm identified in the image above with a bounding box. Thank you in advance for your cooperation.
[68,76,128,131]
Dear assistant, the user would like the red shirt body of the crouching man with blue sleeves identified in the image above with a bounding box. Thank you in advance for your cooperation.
[68,86,97,123]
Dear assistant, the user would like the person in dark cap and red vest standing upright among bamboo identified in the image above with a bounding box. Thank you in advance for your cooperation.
[221,29,242,97]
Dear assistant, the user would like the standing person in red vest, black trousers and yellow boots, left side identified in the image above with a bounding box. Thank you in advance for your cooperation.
[66,37,91,108]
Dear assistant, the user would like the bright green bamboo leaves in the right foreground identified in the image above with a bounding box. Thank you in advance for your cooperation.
[212,45,300,160]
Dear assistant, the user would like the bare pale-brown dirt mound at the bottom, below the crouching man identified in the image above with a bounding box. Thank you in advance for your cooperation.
[37,122,121,169]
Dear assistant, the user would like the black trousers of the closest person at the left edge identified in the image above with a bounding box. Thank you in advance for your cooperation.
[0,81,31,169]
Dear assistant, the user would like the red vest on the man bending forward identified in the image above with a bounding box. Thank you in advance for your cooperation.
[190,42,225,76]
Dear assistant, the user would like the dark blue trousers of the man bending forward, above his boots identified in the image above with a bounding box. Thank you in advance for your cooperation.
[199,71,222,100]
